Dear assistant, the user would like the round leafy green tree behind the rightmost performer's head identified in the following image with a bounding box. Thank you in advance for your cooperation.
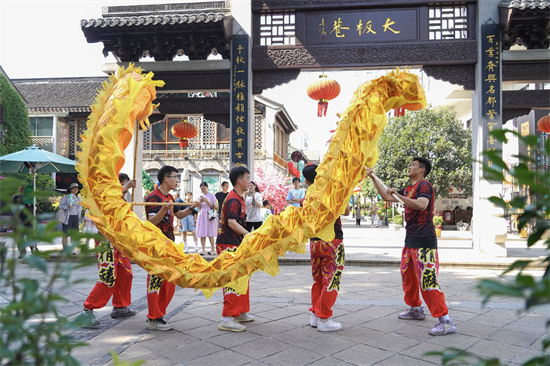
[374,107,473,197]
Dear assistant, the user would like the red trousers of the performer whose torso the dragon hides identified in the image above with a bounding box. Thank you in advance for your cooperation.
[309,239,346,319]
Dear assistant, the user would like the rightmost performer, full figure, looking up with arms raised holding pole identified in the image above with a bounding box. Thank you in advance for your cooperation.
[367,157,456,336]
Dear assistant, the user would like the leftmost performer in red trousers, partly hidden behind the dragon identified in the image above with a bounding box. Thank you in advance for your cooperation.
[81,173,136,326]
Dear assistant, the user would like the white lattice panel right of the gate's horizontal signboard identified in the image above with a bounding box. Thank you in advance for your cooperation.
[429,5,468,40]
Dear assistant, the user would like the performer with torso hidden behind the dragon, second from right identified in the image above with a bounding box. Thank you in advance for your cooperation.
[302,164,349,332]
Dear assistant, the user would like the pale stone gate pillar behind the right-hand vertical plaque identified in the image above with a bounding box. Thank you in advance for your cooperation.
[472,0,507,256]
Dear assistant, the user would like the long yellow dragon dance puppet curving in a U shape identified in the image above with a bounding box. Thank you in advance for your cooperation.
[77,65,426,297]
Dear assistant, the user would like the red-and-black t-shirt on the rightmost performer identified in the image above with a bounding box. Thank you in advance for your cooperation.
[398,180,437,249]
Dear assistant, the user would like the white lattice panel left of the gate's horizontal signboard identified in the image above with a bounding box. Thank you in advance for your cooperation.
[260,11,296,46]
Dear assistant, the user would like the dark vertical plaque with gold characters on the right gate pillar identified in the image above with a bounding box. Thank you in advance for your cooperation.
[481,24,502,176]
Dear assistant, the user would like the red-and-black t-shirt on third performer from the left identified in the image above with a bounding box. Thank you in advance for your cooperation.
[216,190,246,245]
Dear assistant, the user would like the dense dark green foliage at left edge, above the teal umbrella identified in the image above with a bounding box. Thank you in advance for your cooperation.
[0,74,32,156]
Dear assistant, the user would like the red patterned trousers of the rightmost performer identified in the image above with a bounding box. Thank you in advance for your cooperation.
[401,248,449,318]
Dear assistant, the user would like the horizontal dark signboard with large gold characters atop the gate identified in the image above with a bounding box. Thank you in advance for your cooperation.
[306,9,418,44]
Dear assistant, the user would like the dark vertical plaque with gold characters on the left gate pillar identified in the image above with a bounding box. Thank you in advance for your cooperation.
[230,34,253,168]
